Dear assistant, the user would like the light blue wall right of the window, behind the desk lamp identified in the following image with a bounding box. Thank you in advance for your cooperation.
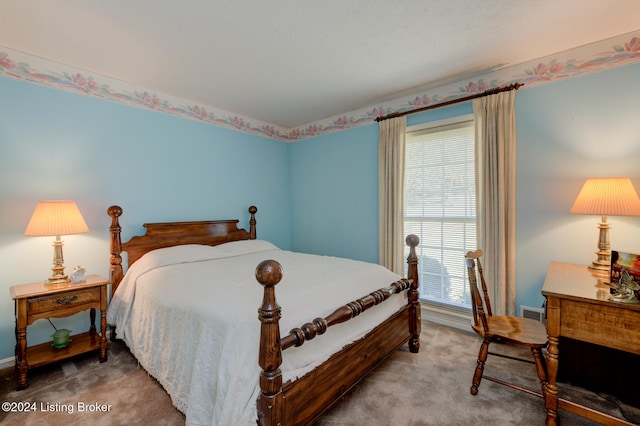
[516,64,640,306]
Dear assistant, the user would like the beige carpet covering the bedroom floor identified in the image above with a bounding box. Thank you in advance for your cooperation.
[0,322,640,426]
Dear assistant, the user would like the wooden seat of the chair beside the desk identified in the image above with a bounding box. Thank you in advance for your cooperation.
[473,315,547,348]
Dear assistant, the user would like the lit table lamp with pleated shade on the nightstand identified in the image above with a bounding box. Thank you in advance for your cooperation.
[24,201,89,285]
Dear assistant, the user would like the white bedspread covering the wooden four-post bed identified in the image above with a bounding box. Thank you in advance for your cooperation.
[107,240,406,426]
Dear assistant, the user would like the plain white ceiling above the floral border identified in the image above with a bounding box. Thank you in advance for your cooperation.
[0,0,640,128]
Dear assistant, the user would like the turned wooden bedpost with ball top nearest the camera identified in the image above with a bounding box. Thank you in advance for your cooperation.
[256,260,284,426]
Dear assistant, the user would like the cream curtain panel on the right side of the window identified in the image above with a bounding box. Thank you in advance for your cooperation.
[473,90,516,315]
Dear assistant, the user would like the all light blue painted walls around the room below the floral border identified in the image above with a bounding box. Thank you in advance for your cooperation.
[0,64,640,360]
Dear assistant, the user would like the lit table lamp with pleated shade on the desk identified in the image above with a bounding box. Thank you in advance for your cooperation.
[570,178,640,271]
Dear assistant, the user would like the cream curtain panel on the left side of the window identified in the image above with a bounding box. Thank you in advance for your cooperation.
[378,117,406,275]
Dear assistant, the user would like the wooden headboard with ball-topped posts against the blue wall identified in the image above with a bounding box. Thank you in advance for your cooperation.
[107,206,258,294]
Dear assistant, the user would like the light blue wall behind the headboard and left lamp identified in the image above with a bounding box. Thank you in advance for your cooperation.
[0,78,291,360]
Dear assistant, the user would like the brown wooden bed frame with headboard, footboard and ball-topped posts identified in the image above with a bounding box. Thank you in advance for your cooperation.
[108,206,421,426]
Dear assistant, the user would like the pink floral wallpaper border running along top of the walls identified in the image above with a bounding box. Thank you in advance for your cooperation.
[0,30,640,142]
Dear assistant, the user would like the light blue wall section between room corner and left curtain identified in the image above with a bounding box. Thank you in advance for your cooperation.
[291,126,378,262]
